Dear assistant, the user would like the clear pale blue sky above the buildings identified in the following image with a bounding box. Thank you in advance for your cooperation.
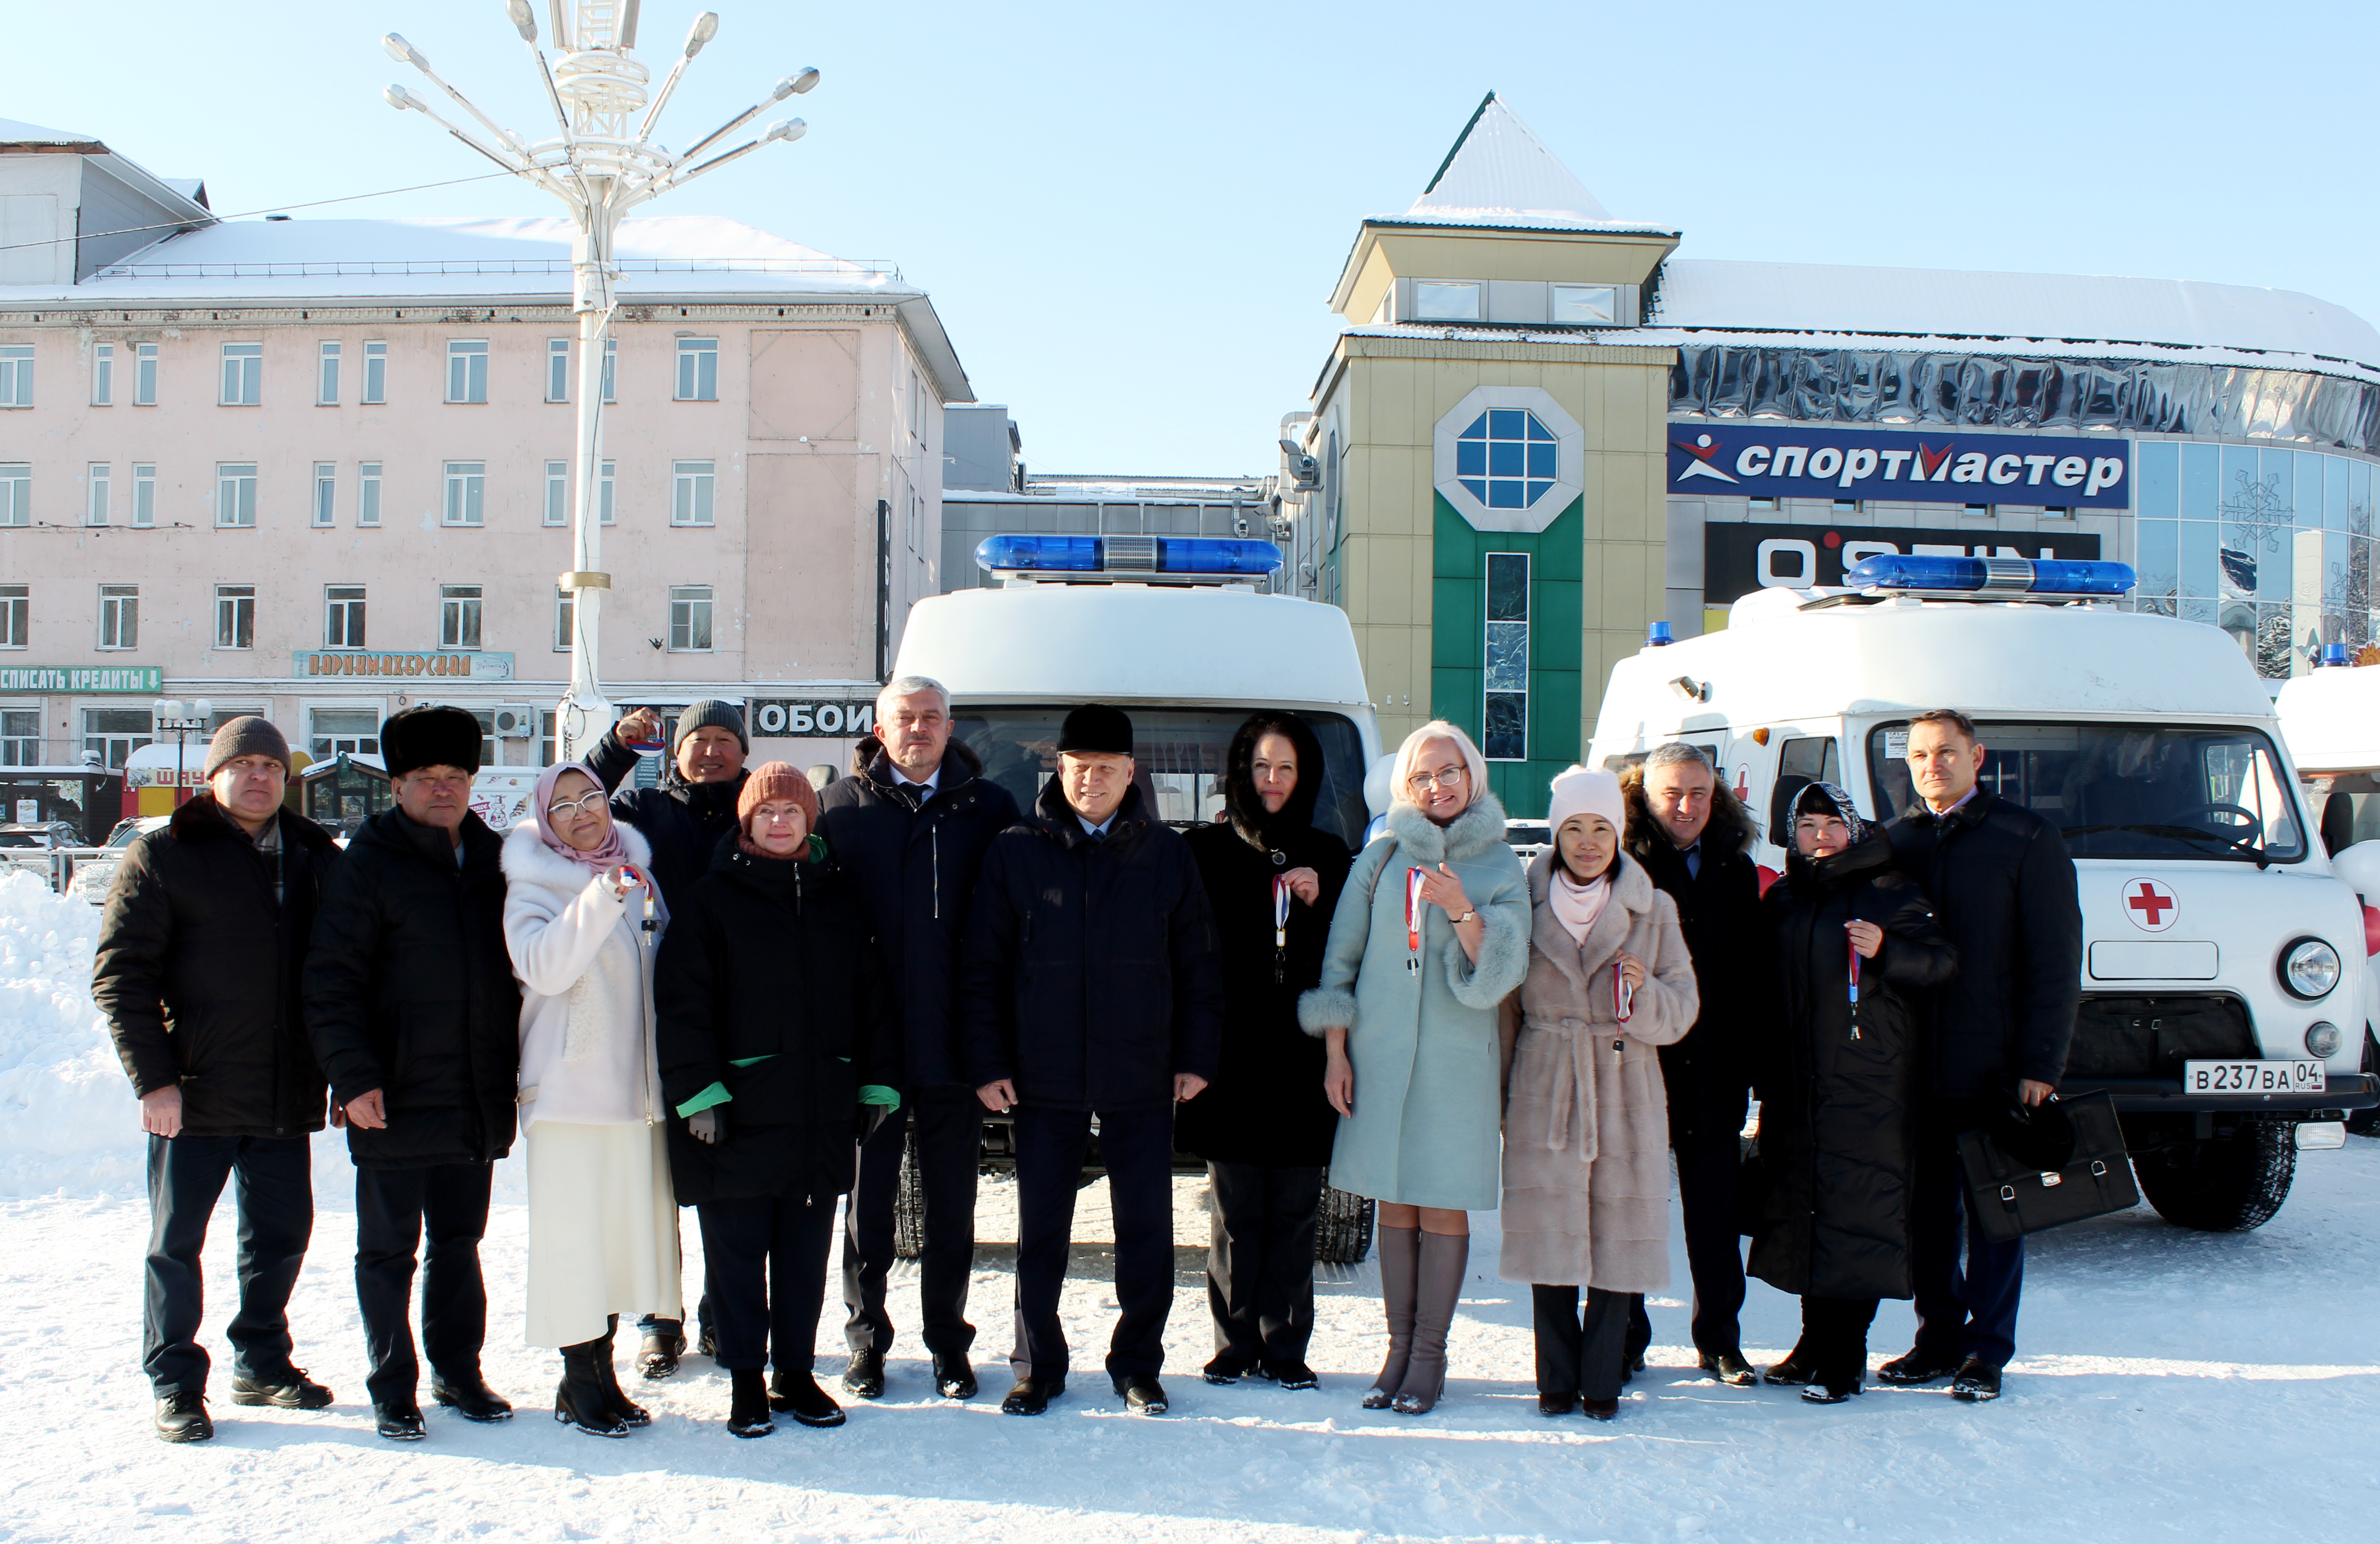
[0,0,2380,474]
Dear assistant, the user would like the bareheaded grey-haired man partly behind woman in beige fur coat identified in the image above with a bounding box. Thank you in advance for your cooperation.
[1621,740,1773,1387]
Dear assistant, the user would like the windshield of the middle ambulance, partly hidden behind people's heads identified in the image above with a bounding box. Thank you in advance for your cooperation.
[952,704,1371,850]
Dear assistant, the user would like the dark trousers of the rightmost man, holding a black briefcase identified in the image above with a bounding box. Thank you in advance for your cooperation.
[1909,1099,2026,1368]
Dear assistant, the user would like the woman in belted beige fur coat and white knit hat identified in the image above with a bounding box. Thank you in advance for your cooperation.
[1502,766,1699,1420]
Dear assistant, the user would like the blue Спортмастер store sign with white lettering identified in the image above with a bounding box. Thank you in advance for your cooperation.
[1668,421,2132,509]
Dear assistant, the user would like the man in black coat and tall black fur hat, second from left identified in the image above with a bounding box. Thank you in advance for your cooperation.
[305,707,521,1442]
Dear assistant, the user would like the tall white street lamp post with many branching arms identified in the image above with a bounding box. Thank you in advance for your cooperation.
[381,0,819,761]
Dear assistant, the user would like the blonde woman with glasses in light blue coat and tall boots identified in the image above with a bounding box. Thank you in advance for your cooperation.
[1297,721,1528,1416]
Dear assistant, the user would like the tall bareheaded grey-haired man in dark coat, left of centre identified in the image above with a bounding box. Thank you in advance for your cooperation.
[819,676,1016,1399]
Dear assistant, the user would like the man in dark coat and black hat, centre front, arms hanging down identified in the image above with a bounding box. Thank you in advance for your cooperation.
[959,704,1223,1416]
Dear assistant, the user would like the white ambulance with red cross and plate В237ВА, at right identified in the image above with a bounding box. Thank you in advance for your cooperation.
[1590,557,2380,1230]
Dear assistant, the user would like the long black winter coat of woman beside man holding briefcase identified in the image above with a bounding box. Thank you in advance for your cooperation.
[1749,830,1956,1296]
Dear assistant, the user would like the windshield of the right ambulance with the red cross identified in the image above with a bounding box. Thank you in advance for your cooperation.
[1868,723,2306,864]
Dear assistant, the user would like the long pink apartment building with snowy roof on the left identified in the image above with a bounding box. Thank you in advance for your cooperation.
[0,121,974,785]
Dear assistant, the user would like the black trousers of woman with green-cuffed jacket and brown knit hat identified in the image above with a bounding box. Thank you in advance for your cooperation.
[695,1197,836,1373]
